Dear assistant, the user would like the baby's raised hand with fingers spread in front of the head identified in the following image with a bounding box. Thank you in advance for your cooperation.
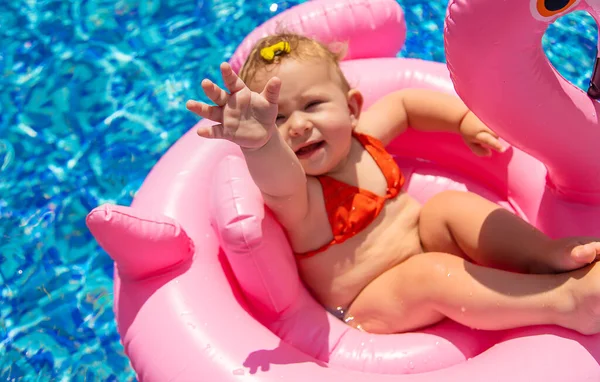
[186,63,281,149]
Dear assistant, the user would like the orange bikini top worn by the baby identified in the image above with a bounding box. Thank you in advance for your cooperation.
[295,132,404,258]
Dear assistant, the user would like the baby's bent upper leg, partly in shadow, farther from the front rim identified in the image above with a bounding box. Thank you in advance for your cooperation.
[419,191,600,273]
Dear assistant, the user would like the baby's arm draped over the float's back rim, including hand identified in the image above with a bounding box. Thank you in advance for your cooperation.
[358,89,504,155]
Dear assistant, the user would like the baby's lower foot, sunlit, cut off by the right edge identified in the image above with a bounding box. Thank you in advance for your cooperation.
[557,262,600,334]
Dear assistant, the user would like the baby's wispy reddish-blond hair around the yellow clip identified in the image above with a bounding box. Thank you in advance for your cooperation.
[239,32,351,90]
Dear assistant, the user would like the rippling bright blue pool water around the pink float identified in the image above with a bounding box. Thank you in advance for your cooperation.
[0,0,596,381]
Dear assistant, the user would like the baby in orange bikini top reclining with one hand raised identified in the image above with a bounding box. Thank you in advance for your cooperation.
[187,33,600,334]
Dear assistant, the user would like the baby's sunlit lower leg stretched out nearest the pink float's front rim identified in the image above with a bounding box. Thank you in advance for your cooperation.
[346,252,600,334]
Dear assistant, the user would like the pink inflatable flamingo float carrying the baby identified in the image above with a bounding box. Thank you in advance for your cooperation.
[87,0,600,382]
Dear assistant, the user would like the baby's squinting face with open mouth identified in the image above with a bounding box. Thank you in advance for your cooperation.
[248,59,360,175]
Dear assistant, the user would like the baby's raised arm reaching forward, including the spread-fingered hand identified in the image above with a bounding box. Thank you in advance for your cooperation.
[186,63,308,228]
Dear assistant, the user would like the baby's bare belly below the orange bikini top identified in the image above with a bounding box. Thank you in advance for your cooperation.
[298,194,422,309]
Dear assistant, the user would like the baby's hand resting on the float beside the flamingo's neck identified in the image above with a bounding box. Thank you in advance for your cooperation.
[460,111,506,156]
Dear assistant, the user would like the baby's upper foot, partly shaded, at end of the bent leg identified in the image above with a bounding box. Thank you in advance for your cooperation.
[539,237,600,273]
